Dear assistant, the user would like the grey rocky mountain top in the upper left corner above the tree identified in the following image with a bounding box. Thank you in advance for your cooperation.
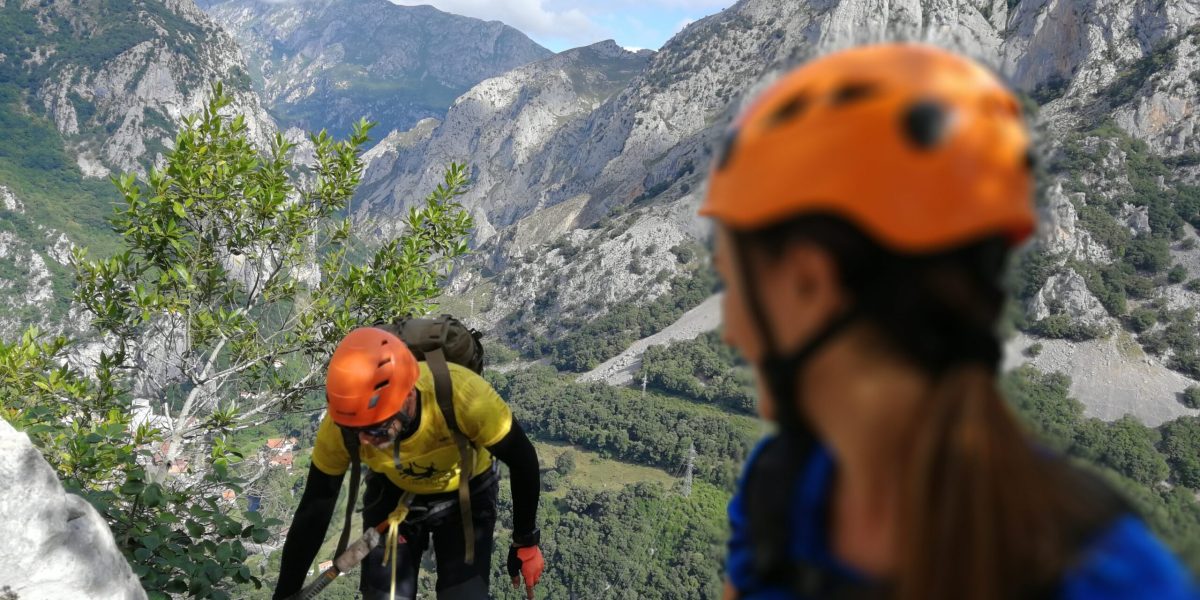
[0,0,274,176]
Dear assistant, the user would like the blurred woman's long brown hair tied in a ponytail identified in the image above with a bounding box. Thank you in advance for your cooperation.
[752,216,1105,600]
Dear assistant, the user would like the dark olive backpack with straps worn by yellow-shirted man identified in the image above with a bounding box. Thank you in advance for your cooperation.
[334,314,484,564]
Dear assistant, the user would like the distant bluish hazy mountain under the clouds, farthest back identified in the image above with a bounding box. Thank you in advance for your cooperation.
[202,0,553,134]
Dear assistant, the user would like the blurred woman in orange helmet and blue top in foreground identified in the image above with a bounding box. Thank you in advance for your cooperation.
[701,44,1196,600]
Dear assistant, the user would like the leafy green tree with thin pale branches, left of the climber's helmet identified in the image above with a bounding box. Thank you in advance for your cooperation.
[76,86,473,468]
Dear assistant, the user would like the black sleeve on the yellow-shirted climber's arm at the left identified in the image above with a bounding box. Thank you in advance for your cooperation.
[274,464,344,599]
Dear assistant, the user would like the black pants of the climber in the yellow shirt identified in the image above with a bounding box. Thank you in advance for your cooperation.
[359,472,499,600]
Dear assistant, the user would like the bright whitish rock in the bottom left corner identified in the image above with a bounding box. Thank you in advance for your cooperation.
[0,420,146,600]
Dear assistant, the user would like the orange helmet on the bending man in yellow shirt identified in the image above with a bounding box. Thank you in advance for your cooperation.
[325,328,419,427]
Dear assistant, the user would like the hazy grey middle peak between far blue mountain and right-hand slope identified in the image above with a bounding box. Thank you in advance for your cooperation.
[359,41,649,242]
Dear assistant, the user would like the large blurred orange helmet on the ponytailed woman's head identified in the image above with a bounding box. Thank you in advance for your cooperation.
[700,44,1034,253]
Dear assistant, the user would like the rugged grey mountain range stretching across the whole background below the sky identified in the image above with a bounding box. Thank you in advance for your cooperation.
[0,0,1200,422]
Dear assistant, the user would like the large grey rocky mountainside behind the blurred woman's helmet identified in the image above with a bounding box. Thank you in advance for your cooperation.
[372,0,1200,422]
